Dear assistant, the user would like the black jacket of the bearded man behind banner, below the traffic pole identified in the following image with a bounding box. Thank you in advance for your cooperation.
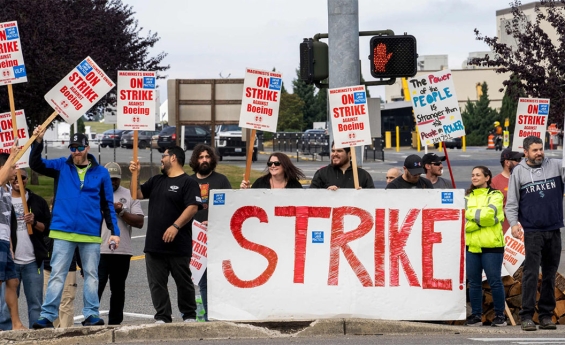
[310,164,375,189]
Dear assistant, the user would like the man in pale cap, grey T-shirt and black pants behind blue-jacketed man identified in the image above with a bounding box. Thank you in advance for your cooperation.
[98,162,144,325]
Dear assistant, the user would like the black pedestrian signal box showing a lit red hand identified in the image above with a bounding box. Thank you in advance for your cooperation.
[369,35,418,78]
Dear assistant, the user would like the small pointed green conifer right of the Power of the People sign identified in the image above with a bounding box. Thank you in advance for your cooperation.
[461,83,500,146]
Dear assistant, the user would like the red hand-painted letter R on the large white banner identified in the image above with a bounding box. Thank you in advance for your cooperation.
[328,206,373,287]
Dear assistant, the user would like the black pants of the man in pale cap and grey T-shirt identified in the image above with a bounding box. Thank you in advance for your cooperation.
[98,254,131,325]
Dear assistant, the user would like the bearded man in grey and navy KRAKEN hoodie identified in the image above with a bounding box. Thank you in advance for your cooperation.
[505,136,565,331]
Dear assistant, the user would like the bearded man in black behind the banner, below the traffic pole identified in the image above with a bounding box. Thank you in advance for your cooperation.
[310,143,375,191]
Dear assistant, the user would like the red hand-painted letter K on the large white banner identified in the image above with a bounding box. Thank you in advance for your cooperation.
[389,209,420,286]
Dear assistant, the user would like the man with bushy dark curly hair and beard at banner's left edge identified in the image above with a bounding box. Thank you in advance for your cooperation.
[189,144,231,321]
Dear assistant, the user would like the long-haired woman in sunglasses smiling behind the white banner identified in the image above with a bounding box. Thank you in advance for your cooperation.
[240,152,304,189]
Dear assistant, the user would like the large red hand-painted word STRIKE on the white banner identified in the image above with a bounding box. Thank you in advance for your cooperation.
[222,206,464,290]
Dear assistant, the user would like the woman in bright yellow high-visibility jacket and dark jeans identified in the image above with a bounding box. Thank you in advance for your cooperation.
[465,166,506,326]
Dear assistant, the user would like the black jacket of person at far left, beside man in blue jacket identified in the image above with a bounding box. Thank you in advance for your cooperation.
[10,189,51,267]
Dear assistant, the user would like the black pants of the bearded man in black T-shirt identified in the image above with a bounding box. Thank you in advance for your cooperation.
[145,253,196,323]
